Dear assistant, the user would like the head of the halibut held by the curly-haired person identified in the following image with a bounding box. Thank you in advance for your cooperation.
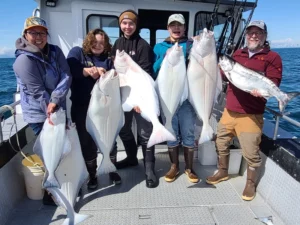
[98,69,120,95]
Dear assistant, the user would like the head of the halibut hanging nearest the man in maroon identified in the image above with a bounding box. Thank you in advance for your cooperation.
[193,28,216,58]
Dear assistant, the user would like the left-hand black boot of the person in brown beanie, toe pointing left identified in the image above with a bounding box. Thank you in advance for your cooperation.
[116,138,139,170]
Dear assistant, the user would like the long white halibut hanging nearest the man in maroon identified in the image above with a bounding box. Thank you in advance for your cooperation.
[187,28,222,144]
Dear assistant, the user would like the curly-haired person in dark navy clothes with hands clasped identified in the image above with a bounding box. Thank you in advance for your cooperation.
[67,29,121,189]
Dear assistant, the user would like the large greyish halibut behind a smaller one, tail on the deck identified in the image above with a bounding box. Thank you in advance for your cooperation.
[47,124,91,225]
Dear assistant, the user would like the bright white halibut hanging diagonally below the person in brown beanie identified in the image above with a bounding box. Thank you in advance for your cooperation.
[114,50,176,148]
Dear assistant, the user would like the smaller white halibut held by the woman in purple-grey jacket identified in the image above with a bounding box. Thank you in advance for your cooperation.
[33,108,71,188]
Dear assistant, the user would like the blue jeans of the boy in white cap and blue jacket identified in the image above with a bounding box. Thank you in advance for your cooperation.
[167,100,196,148]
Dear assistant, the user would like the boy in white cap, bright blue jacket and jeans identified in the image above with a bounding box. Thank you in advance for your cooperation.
[153,14,199,183]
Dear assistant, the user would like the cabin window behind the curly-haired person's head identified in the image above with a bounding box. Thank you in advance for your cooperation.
[86,14,120,44]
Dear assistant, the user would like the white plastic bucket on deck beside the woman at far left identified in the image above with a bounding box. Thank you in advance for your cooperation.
[22,155,44,200]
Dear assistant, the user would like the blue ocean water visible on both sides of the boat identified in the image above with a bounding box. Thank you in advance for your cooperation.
[0,48,300,137]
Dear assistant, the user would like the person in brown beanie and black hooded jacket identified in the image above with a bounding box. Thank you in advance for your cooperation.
[112,10,158,188]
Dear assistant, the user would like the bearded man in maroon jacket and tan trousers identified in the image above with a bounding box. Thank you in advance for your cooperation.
[206,21,282,201]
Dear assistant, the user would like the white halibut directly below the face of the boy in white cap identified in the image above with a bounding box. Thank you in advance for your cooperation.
[156,42,188,134]
